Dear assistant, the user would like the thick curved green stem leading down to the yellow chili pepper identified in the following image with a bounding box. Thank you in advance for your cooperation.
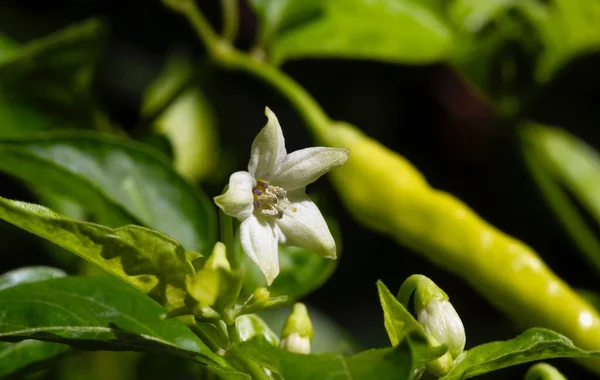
[163,0,331,137]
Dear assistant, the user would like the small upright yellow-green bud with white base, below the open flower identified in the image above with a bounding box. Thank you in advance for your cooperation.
[279,303,313,354]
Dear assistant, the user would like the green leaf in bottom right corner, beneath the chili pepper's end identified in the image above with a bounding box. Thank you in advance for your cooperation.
[442,328,600,380]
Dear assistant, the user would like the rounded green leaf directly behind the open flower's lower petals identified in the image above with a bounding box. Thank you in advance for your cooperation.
[235,218,341,303]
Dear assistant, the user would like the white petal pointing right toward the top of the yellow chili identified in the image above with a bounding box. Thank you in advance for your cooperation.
[271,147,350,191]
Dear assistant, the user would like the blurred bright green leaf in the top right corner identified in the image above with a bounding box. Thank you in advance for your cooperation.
[521,0,600,82]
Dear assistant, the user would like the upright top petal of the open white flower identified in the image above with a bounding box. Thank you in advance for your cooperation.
[248,107,287,179]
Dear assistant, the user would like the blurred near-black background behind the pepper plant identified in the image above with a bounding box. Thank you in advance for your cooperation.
[0,0,600,379]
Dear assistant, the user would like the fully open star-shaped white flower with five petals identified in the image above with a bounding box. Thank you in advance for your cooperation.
[215,107,349,285]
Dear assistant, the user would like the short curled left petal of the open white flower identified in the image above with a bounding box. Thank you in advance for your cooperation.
[214,172,256,220]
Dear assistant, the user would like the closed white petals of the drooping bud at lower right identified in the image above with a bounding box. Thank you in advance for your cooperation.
[417,299,467,359]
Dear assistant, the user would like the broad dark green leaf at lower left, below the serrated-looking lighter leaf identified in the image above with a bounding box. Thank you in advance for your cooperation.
[0,277,237,372]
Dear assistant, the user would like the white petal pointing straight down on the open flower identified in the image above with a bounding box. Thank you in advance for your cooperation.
[240,215,279,285]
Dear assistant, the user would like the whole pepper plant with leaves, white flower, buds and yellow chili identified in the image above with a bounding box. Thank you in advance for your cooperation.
[0,0,600,380]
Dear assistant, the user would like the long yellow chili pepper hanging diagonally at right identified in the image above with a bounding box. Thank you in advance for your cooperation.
[318,123,600,373]
